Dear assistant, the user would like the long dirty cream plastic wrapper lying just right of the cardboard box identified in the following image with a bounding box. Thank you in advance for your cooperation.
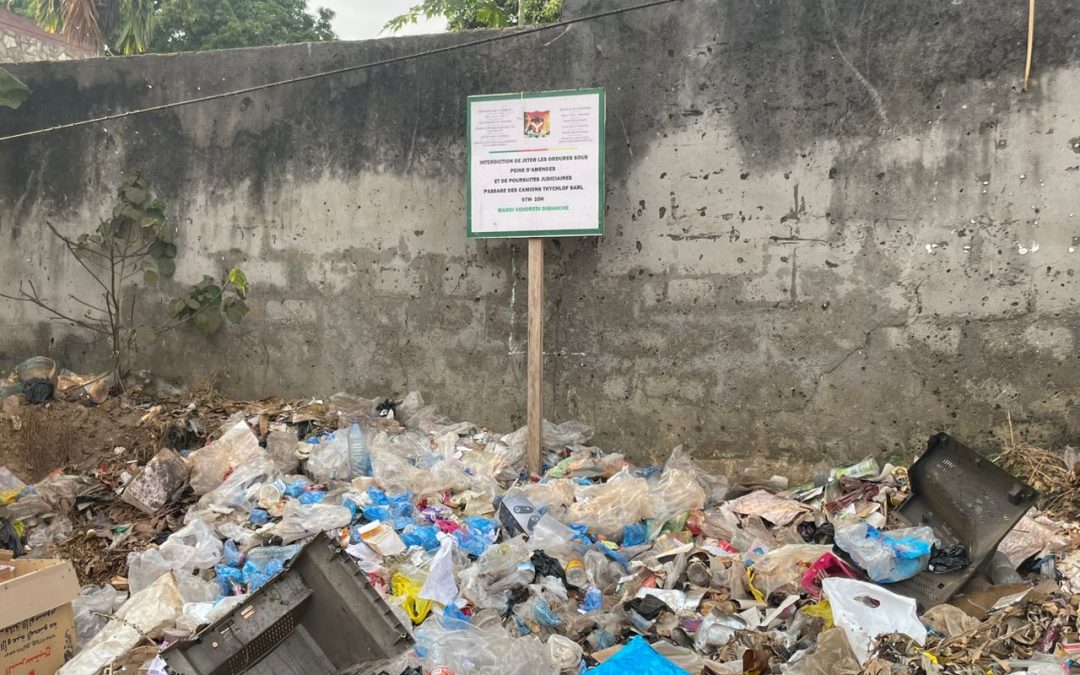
[57,573,184,675]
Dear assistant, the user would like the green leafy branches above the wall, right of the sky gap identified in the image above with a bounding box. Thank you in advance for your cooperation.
[383,0,563,31]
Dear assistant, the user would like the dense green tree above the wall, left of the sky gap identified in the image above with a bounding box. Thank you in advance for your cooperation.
[150,0,337,52]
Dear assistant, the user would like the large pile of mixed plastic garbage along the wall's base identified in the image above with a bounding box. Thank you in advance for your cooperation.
[0,393,1080,675]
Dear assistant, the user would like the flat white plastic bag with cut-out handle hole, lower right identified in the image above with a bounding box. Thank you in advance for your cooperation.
[822,578,927,665]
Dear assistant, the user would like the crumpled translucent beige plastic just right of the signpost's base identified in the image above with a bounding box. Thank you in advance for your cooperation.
[568,469,656,540]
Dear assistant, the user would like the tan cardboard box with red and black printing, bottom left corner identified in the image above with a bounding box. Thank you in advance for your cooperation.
[0,558,79,675]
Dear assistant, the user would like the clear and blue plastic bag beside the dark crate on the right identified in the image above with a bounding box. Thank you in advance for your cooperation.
[836,523,937,583]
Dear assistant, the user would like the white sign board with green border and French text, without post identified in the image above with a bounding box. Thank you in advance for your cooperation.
[465,89,605,238]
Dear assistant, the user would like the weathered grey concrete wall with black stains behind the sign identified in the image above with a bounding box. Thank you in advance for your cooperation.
[0,0,1080,462]
